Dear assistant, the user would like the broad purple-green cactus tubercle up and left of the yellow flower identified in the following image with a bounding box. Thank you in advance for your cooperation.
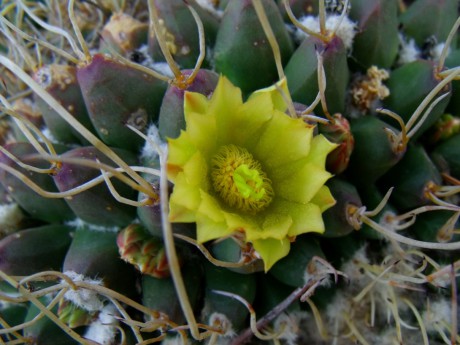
[77,54,166,150]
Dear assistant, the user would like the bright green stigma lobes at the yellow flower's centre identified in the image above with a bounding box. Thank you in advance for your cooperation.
[233,164,265,200]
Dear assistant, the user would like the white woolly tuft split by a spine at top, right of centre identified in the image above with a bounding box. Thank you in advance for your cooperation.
[295,14,356,49]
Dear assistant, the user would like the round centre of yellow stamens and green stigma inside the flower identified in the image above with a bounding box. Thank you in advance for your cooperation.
[211,145,274,213]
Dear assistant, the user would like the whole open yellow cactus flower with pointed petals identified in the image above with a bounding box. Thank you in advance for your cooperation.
[168,77,336,271]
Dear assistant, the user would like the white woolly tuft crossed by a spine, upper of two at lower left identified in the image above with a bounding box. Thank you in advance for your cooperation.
[62,271,104,311]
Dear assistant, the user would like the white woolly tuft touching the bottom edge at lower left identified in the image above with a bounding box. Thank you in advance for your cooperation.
[84,304,118,345]
